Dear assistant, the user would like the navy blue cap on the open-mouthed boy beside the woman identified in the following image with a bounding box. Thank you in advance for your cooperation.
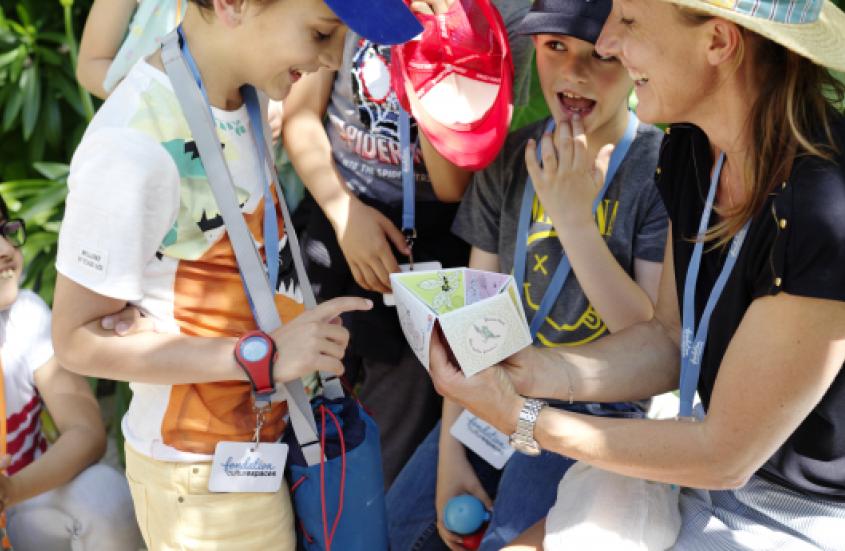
[516,0,613,44]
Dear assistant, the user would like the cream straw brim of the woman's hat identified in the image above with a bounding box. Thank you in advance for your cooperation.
[663,0,845,71]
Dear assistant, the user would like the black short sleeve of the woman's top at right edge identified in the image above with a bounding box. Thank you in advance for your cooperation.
[769,159,845,301]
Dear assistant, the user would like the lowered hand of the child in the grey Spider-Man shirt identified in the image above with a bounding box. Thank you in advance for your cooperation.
[326,194,410,293]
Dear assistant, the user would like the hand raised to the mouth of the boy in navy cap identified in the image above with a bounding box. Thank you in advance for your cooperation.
[525,116,613,230]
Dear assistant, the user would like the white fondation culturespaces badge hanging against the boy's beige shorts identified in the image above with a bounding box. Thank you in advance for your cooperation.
[208,442,288,493]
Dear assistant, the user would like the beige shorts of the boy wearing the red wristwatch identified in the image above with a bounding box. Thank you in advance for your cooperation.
[126,444,296,551]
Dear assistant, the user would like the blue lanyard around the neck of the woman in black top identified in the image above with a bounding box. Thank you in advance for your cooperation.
[679,153,751,417]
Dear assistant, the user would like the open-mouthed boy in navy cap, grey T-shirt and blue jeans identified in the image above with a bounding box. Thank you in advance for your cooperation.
[388,0,667,551]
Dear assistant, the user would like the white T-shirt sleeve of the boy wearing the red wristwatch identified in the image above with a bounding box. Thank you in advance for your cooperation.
[56,128,180,301]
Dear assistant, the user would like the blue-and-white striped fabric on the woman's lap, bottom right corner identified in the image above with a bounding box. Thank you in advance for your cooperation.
[672,476,845,551]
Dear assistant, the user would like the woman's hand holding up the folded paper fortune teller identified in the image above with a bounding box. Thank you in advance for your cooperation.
[429,325,525,434]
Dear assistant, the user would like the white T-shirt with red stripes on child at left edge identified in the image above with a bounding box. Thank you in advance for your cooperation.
[0,289,53,475]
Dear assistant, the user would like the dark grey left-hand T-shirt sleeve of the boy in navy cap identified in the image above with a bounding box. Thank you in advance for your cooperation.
[452,154,506,254]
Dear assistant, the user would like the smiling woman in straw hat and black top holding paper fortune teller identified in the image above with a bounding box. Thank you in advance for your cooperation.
[431,0,845,551]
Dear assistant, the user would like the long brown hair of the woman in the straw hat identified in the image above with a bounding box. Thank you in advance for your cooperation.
[676,6,845,246]
